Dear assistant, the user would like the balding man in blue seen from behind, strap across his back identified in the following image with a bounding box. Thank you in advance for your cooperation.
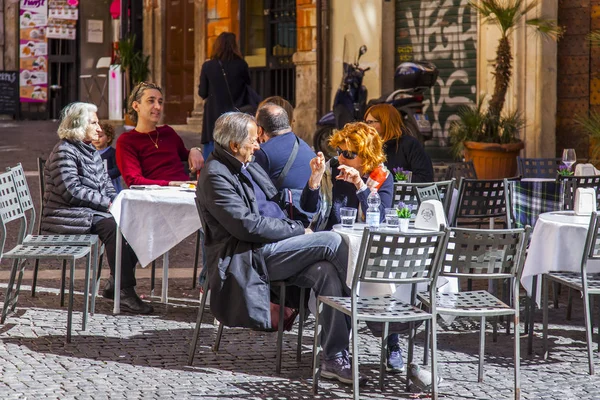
[254,103,315,226]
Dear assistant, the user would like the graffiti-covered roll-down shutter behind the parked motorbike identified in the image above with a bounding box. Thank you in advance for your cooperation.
[396,0,477,144]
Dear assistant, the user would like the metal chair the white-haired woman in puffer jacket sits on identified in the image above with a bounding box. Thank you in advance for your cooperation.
[28,157,104,314]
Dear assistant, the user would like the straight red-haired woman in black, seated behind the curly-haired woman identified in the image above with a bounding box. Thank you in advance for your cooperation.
[365,104,433,182]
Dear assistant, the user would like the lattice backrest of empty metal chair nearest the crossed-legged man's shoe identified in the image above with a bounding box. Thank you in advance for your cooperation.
[352,228,447,297]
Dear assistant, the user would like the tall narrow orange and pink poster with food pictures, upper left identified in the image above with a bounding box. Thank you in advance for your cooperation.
[19,0,48,103]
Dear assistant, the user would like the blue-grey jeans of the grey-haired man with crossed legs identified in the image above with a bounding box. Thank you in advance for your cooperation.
[263,232,351,360]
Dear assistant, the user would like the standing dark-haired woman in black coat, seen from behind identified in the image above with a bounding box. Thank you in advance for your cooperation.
[198,32,250,160]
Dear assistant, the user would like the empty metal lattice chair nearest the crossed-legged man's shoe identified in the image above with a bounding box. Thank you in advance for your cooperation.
[313,228,447,399]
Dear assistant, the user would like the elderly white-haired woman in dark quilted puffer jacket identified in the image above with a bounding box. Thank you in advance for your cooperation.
[41,103,153,314]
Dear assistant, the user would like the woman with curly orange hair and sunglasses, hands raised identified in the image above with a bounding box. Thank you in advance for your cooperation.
[300,122,404,372]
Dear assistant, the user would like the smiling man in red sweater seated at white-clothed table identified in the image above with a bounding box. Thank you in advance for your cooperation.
[116,82,204,186]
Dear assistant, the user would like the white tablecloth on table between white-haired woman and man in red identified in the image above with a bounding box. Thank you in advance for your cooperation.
[110,187,201,266]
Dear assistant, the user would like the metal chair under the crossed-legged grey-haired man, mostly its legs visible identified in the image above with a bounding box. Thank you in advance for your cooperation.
[188,212,309,374]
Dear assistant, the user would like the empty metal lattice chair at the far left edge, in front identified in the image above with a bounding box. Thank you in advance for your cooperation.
[0,172,91,343]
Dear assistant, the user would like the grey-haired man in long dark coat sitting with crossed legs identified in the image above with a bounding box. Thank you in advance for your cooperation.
[196,113,360,383]
